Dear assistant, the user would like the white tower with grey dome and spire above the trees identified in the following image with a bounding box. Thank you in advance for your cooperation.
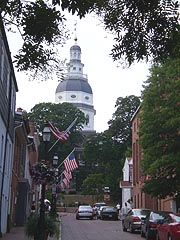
[55,38,96,133]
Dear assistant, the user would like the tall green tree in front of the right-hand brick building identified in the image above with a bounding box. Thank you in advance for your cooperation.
[140,59,180,198]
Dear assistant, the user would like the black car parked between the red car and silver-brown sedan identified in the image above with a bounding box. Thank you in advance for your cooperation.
[141,211,170,240]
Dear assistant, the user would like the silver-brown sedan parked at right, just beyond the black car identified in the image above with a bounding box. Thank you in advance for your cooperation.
[122,208,151,233]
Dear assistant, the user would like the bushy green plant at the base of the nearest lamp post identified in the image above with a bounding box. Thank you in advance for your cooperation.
[25,214,59,240]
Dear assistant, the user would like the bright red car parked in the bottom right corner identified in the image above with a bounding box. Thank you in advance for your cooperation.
[157,213,180,240]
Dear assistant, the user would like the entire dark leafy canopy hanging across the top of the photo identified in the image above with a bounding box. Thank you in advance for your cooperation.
[0,0,180,75]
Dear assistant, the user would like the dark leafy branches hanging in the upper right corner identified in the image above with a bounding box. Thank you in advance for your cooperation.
[103,0,179,65]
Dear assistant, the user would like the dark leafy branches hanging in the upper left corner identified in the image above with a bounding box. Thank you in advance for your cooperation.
[0,0,68,76]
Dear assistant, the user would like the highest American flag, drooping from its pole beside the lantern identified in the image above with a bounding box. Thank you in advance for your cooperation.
[49,118,77,142]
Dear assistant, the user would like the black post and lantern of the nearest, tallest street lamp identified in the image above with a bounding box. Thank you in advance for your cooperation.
[38,124,51,240]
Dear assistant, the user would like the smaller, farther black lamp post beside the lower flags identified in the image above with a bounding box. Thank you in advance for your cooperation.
[51,153,59,217]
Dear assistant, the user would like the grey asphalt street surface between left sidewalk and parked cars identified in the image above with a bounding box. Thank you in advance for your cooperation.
[61,213,142,240]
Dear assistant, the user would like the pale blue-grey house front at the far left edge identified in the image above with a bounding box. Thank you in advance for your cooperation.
[0,14,18,235]
